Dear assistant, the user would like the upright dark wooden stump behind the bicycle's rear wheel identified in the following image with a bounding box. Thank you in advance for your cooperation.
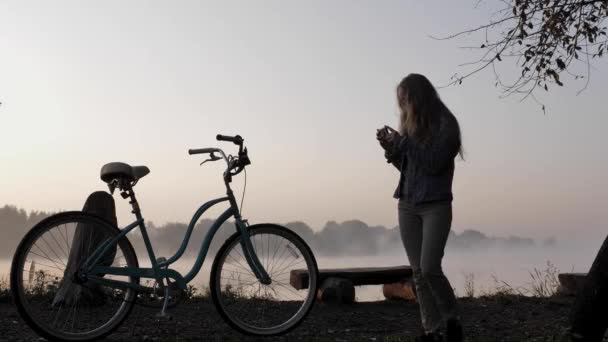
[53,191,117,306]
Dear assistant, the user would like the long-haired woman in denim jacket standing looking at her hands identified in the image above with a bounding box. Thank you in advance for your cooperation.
[377,74,462,341]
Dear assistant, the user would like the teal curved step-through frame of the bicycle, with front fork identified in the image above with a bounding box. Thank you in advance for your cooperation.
[81,174,269,290]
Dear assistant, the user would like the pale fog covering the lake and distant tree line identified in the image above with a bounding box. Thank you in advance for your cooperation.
[0,206,602,301]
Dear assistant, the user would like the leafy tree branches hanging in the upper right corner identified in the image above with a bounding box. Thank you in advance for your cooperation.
[438,0,608,104]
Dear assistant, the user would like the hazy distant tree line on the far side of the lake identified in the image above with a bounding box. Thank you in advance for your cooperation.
[0,205,556,259]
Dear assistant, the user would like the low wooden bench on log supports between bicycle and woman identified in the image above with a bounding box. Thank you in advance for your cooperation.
[289,266,415,303]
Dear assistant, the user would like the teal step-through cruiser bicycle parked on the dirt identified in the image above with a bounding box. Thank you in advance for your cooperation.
[11,135,318,341]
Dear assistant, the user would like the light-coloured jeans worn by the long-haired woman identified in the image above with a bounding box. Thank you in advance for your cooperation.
[398,199,459,333]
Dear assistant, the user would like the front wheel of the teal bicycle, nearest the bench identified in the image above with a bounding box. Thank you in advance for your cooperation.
[209,224,318,336]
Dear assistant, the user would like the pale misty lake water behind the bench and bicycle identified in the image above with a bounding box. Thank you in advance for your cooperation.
[0,241,601,301]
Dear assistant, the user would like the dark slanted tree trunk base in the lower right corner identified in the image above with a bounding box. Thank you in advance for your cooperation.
[570,237,608,341]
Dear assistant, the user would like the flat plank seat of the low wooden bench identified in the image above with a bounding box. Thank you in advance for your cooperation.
[289,266,412,290]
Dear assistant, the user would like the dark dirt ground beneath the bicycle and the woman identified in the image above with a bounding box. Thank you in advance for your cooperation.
[0,296,573,341]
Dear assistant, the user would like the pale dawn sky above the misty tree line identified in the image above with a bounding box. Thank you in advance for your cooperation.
[0,0,608,239]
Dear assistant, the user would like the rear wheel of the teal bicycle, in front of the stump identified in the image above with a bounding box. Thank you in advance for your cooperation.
[11,212,139,341]
